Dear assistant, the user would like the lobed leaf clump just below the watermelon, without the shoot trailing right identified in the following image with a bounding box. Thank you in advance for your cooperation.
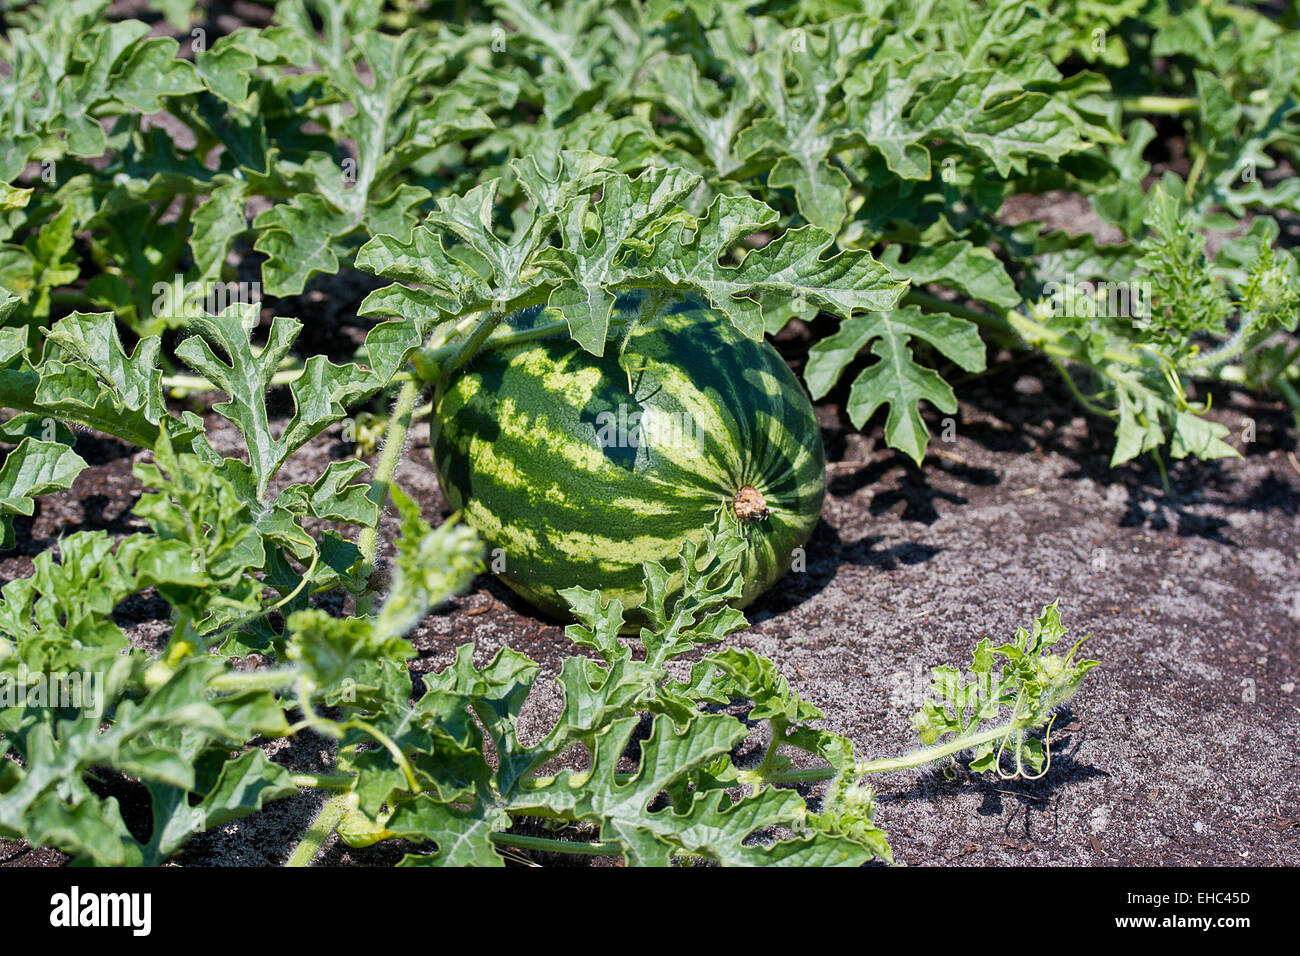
[342,530,888,865]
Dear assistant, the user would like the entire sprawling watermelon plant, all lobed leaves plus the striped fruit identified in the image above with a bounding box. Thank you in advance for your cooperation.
[0,0,1300,864]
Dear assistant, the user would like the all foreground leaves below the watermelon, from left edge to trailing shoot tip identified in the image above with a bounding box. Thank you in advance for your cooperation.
[0,492,1093,865]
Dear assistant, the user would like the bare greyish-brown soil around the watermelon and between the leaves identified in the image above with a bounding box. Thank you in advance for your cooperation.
[0,343,1300,865]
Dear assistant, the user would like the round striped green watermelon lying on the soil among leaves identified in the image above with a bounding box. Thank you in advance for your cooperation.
[430,303,826,622]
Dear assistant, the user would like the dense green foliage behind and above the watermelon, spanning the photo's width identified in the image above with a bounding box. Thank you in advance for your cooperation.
[0,0,1300,465]
